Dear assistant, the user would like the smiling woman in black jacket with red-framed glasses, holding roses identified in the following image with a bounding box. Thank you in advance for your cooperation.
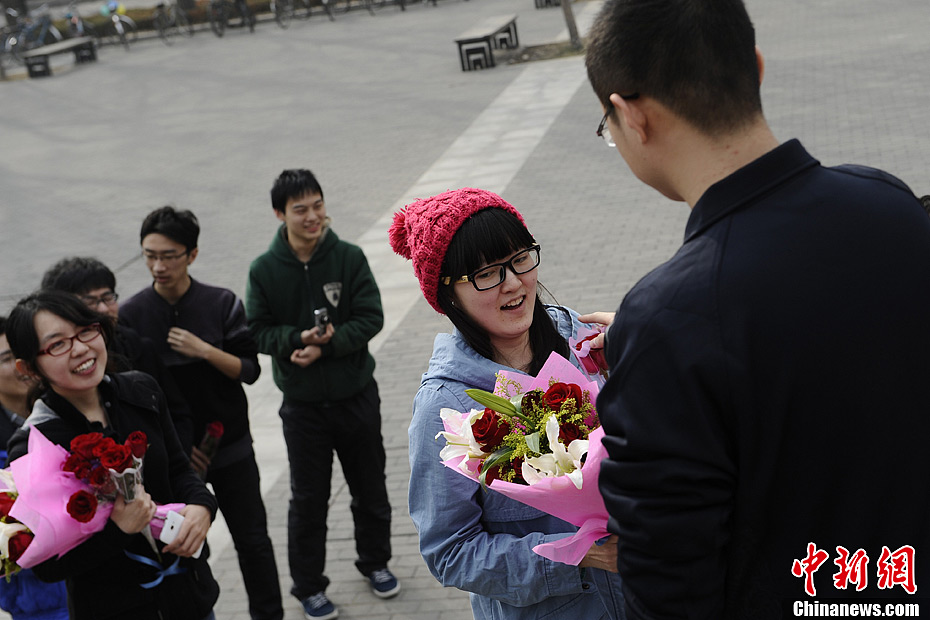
[6,290,219,620]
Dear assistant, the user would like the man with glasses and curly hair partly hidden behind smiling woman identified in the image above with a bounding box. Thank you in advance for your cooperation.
[41,256,194,454]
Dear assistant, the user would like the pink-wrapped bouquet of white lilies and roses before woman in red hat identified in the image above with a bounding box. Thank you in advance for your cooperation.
[436,353,608,565]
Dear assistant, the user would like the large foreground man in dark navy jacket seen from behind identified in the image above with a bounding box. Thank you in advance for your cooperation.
[582,0,930,620]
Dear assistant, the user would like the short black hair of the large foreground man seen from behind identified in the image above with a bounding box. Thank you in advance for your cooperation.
[585,0,762,136]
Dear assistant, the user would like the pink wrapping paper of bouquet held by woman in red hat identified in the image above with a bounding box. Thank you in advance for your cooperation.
[443,353,608,566]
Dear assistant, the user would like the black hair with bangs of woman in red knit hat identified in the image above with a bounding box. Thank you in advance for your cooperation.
[437,208,569,375]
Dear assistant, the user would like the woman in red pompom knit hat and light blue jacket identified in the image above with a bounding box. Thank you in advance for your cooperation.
[390,189,622,620]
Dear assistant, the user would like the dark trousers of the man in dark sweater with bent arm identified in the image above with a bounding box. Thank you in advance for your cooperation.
[207,453,284,620]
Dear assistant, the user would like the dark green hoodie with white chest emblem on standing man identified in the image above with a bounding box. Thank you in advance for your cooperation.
[245,224,384,403]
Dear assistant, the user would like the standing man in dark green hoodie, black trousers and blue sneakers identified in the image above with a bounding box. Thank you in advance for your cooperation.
[246,170,400,618]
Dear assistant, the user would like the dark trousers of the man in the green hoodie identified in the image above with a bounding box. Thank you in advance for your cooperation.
[281,380,391,600]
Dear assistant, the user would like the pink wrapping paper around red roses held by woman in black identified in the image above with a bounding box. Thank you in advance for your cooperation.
[9,428,184,568]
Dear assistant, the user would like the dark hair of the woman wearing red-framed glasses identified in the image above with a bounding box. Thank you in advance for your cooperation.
[6,290,113,409]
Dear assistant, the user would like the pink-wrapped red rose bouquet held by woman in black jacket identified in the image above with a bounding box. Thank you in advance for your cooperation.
[0,428,184,574]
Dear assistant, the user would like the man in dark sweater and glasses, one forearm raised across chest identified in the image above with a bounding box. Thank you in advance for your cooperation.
[120,206,284,620]
